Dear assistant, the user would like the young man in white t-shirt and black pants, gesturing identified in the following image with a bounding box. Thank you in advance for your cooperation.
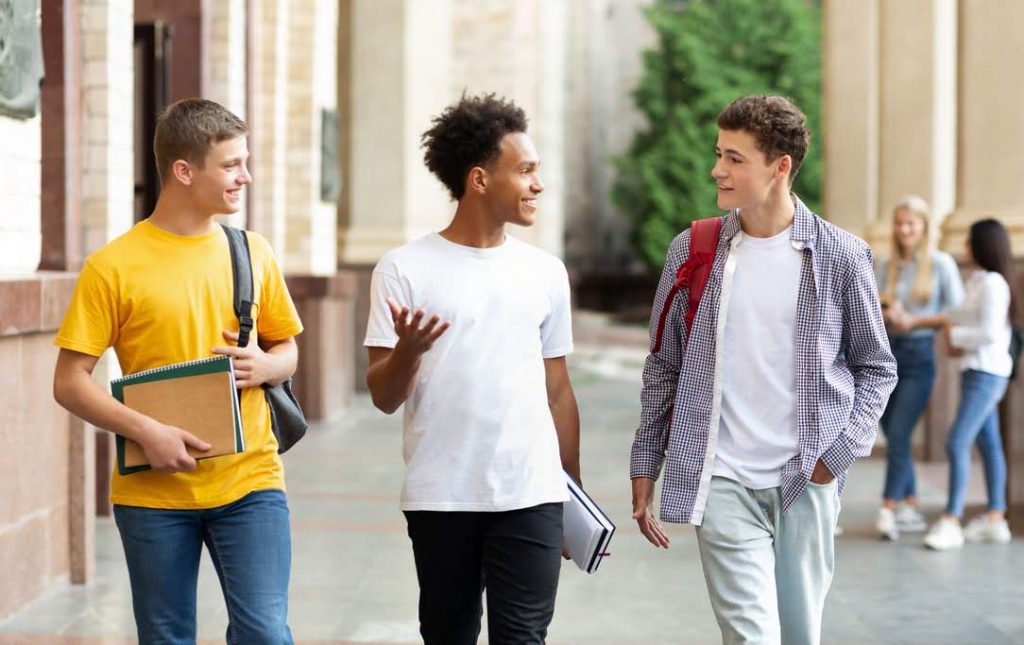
[364,94,580,645]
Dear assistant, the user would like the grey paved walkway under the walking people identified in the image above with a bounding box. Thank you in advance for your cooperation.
[0,335,1024,645]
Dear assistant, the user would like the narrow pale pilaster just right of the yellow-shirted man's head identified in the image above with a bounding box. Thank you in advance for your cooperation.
[250,0,291,258]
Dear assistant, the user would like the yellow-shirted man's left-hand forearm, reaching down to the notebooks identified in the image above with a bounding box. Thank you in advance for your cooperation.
[53,373,153,443]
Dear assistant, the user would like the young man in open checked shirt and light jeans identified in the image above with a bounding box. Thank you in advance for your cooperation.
[630,96,896,645]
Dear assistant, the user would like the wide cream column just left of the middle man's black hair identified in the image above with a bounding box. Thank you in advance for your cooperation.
[339,0,458,264]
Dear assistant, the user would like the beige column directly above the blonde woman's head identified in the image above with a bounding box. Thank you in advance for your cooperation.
[868,0,957,249]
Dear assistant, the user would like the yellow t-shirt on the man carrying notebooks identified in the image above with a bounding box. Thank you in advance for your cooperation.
[54,220,302,509]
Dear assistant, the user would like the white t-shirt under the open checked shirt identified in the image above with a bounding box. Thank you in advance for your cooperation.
[712,228,802,489]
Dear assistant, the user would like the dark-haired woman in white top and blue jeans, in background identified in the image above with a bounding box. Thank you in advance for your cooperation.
[925,219,1017,550]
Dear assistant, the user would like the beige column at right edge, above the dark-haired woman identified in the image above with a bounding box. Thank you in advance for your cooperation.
[942,0,1024,256]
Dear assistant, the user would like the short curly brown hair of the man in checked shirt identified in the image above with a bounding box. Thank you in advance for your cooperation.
[718,94,811,183]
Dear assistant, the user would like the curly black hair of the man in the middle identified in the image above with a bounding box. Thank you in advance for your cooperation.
[422,93,526,201]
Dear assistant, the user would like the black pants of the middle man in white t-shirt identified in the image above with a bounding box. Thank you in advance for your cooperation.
[406,503,562,645]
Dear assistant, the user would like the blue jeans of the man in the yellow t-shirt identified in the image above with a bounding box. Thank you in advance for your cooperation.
[114,490,293,645]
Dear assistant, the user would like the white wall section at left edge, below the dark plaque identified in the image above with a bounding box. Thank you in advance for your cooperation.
[0,116,42,275]
